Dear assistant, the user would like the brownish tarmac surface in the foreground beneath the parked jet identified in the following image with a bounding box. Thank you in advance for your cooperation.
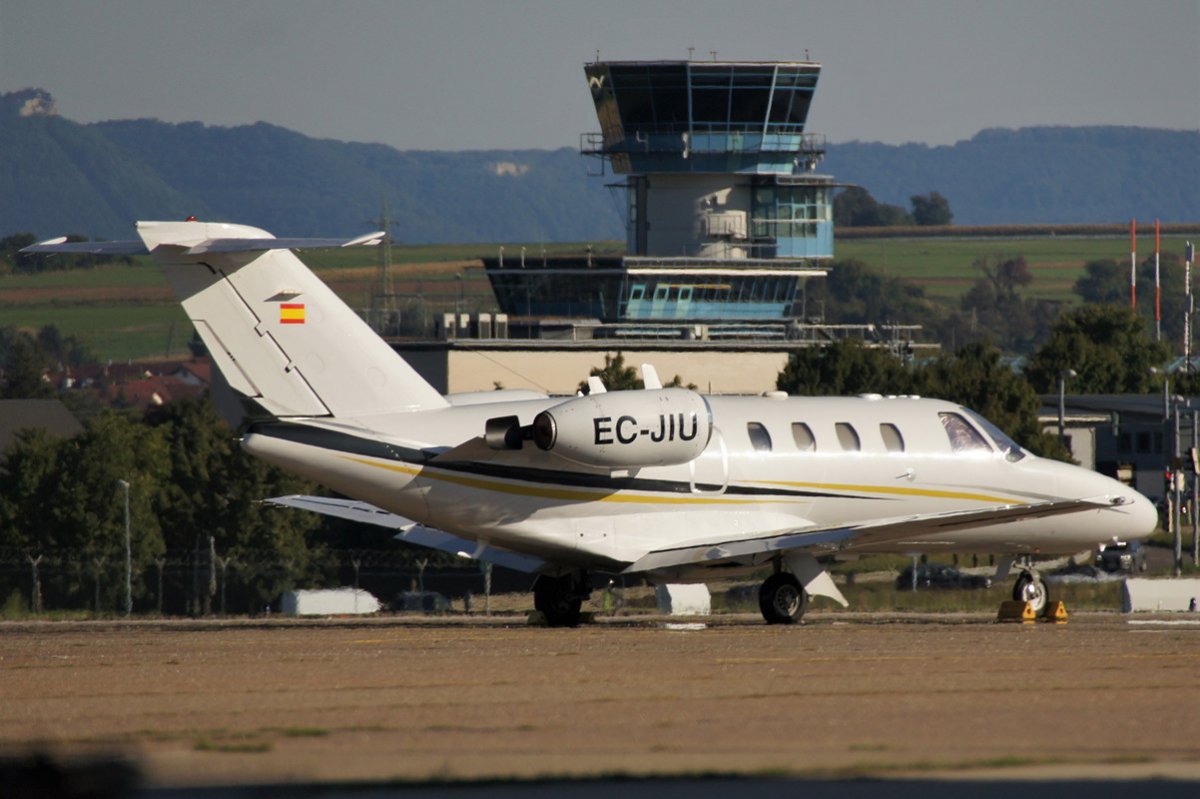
[0,613,1200,795]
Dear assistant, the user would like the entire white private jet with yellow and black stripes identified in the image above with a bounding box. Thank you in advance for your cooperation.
[28,221,1157,625]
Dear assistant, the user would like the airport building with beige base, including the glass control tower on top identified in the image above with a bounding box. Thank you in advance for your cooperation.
[401,60,911,394]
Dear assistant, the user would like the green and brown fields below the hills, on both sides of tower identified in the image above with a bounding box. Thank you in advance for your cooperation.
[0,236,1184,361]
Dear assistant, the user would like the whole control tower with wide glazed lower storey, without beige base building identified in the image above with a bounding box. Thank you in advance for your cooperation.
[484,60,833,338]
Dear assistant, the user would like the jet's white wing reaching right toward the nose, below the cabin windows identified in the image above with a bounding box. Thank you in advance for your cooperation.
[624,498,1117,575]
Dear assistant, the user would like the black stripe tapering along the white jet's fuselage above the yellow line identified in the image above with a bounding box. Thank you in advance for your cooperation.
[247,421,886,499]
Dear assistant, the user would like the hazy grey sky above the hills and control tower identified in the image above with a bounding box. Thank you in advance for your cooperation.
[0,0,1200,150]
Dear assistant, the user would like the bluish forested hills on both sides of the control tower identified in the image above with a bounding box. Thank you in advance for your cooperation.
[0,91,1200,244]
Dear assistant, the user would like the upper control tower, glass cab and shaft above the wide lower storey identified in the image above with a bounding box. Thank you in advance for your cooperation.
[583,61,833,260]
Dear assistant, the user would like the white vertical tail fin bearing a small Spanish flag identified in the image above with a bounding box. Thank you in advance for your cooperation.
[138,222,446,417]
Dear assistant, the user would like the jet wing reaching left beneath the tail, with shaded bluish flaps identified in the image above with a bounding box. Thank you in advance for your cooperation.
[263,494,546,573]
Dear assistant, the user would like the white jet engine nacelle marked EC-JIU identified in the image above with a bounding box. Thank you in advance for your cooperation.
[530,389,713,469]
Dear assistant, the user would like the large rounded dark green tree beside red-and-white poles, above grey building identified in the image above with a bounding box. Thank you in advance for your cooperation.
[1025,305,1170,394]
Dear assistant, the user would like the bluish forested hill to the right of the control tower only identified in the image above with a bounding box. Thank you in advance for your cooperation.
[820,127,1200,224]
